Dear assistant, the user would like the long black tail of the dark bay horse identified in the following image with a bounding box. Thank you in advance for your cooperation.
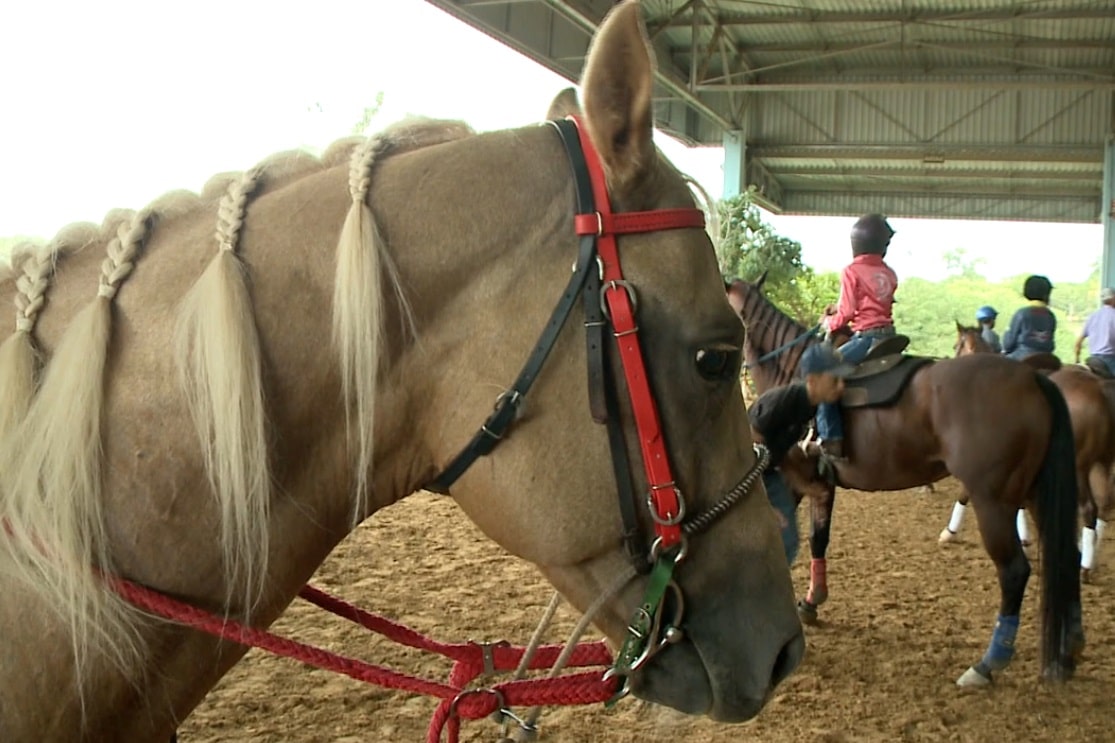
[1034,374,1080,674]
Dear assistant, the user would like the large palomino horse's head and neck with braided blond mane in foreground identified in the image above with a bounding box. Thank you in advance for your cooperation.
[0,0,804,742]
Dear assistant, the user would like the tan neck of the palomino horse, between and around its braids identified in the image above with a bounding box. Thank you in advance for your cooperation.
[0,124,575,741]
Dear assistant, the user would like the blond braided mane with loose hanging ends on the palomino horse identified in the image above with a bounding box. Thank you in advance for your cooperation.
[0,119,472,678]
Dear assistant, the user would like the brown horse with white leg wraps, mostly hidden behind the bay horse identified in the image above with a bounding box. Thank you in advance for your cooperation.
[940,321,1115,580]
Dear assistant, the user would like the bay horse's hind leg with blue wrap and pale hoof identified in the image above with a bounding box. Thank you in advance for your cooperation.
[957,494,1030,686]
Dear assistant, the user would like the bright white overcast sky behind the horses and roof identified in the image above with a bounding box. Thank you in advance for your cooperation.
[0,0,1103,281]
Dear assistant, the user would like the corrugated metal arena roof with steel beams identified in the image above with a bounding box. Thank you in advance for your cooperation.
[429,0,1115,221]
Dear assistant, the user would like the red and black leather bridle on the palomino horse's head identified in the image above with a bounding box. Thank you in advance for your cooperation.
[426,117,767,698]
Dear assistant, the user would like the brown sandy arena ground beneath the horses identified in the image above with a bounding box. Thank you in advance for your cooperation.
[180,480,1115,743]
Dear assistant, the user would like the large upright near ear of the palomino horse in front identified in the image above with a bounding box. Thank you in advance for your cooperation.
[581,0,657,193]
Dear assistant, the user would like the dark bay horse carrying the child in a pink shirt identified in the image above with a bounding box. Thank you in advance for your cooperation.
[729,274,1084,685]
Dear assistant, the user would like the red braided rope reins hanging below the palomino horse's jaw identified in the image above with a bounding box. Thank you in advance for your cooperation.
[105,577,615,743]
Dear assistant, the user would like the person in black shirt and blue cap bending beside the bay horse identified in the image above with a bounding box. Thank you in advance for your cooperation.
[747,344,854,565]
